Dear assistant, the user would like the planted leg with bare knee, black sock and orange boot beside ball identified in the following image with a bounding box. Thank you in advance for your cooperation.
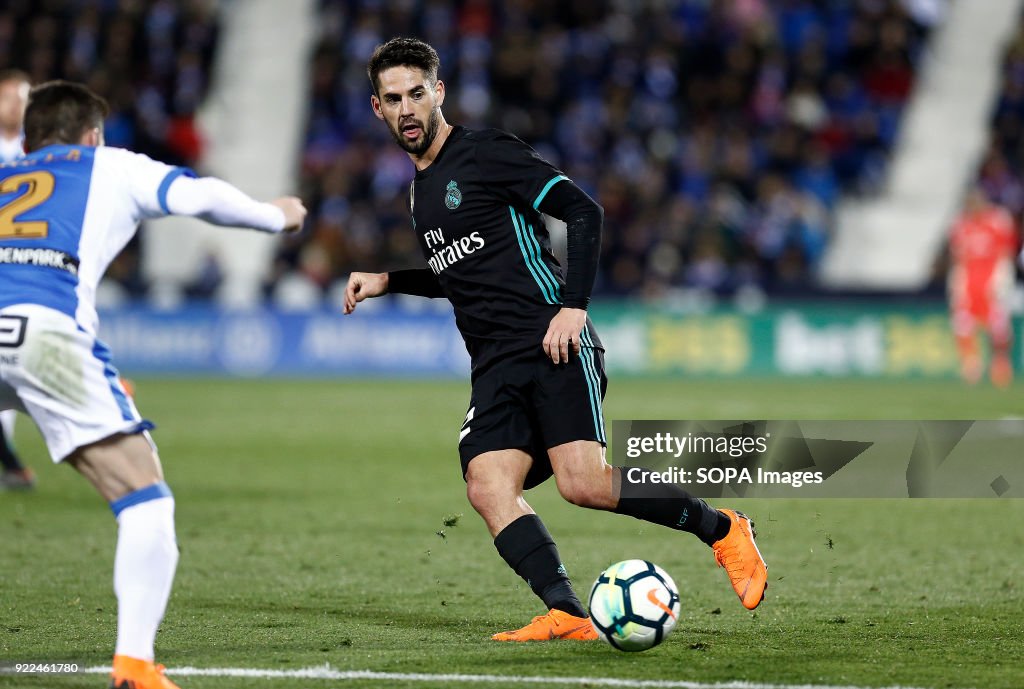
[466,449,592,641]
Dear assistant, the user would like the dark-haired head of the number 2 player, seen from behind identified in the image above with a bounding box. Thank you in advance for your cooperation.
[25,80,111,153]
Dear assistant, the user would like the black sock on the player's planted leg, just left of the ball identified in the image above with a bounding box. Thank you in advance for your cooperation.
[495,514,587,617]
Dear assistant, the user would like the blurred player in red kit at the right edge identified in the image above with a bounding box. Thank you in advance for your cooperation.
[949,186,1018,387]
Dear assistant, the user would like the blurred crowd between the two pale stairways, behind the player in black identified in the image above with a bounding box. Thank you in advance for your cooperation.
[278,0,937,298]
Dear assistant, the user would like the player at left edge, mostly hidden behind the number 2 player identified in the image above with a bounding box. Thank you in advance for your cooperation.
[0,70,36,490]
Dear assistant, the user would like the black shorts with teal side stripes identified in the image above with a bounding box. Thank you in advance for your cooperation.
[459,347,608,488]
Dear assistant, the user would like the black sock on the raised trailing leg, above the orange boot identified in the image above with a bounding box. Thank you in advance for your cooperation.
[613,468,731,546]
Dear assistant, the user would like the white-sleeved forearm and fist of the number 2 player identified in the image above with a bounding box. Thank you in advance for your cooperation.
[165,175,306,232]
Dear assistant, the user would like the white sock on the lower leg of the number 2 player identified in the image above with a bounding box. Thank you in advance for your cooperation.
[114,491,178,660]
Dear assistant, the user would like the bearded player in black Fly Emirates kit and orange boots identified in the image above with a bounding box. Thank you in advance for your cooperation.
[344,38,767,641]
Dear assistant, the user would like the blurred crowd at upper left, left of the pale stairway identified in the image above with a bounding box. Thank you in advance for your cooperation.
[0,0,218,296]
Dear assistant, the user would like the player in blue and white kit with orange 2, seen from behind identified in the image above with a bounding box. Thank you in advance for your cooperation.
[0,82,305,689]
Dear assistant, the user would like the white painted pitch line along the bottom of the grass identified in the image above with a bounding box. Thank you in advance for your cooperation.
[68,665,954,689]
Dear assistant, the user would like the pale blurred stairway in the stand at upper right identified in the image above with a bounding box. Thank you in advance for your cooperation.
[818,0,1024,293]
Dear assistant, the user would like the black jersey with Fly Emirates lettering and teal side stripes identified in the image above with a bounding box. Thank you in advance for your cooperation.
[410,127,601,374]
